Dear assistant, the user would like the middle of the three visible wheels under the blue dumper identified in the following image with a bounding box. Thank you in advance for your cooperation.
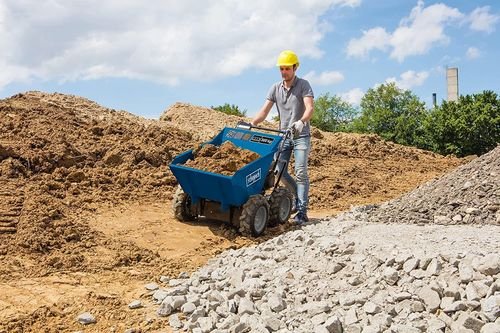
[239,194,269,237]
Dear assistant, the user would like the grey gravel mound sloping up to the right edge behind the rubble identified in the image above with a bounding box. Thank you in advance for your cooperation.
[370,146,500,225]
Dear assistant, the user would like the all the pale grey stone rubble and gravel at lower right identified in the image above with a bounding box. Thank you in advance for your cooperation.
[143,148,500,333]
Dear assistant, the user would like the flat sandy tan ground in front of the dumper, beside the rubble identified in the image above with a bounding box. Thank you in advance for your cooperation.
[0,203,331,332]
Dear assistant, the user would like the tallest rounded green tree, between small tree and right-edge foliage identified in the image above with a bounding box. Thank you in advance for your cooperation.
[352,83,427,147]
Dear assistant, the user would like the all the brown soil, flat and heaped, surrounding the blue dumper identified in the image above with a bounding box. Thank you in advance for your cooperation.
[0,92,464,332]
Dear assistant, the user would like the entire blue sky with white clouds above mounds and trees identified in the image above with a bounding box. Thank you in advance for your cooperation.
[0,0,500,119]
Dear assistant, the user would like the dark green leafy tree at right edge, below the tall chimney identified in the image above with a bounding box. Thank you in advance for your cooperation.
[425,90,500,157]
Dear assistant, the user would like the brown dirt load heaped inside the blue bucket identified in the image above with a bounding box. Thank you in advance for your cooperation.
[184,141,259,176]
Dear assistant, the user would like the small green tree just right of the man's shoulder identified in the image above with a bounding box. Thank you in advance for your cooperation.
[311,93,358,132]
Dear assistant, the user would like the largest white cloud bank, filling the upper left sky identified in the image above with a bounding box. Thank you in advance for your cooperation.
[0,0,360,88]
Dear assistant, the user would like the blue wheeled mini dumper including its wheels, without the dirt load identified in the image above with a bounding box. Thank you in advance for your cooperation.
[170,122,293,237]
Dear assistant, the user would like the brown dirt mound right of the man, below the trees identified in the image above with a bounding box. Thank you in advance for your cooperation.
[310,131,461,210]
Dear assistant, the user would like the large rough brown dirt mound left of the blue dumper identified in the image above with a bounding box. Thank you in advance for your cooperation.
[0,92,192,268]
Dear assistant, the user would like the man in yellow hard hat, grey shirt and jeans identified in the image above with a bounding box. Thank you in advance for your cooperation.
[251,50,314,224]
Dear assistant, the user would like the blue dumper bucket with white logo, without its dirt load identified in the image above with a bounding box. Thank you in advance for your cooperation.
[170,127,282,211]
